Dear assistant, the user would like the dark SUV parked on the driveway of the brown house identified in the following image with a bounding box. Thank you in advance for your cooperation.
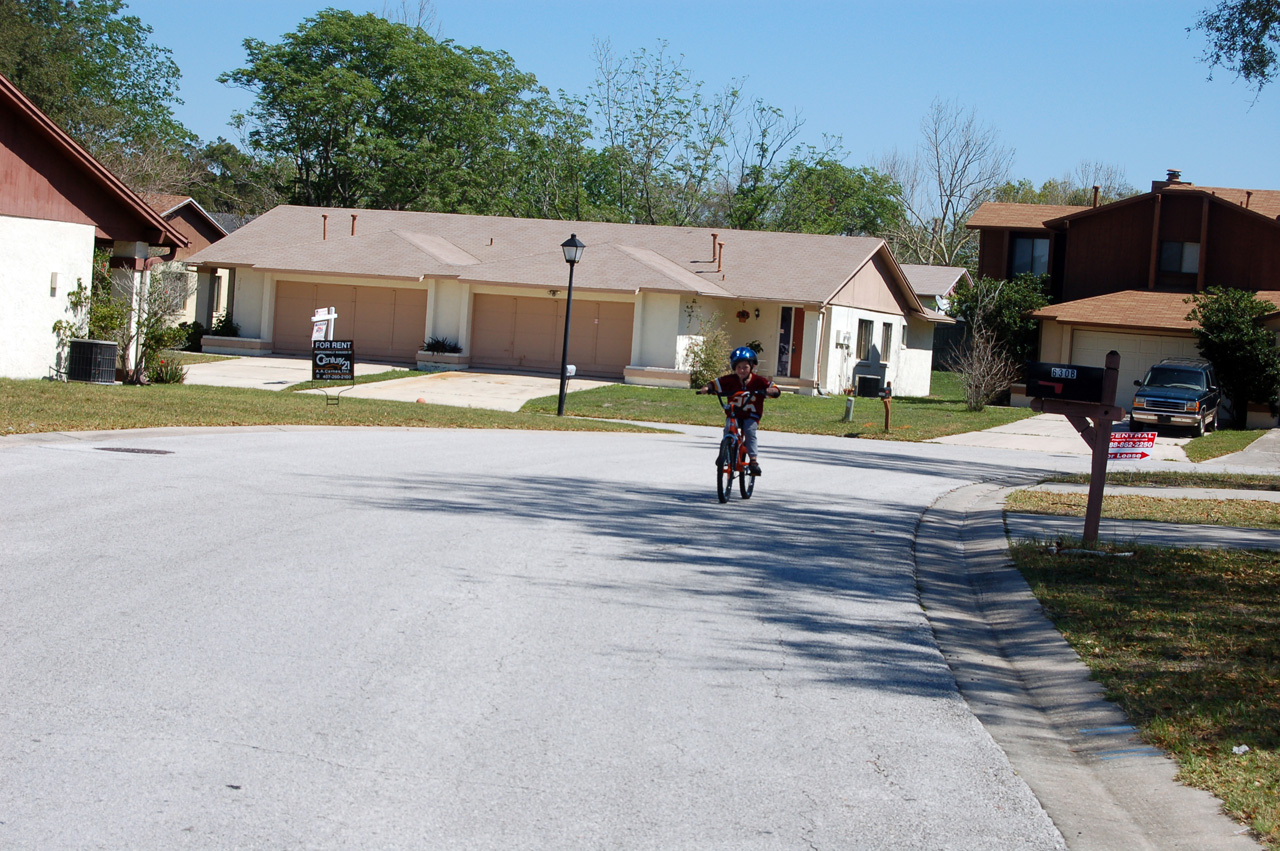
[1129,357,1222,436]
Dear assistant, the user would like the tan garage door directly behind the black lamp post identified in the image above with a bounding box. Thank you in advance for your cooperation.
[471,293,635,379]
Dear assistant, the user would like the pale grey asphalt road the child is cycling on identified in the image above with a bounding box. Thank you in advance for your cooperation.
[0,429,1087,850]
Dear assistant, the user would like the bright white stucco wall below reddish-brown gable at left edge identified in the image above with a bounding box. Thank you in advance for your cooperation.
[0,216,93,379]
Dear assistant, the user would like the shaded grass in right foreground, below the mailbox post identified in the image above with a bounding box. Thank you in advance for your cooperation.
[1010,544,1280,848]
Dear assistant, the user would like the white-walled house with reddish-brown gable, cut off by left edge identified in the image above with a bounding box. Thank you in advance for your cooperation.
[0,76,187,379]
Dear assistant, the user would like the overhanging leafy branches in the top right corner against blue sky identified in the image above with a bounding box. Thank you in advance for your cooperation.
[1188,0,1280,92]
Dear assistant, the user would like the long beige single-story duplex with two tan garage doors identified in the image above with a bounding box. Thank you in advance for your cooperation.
[189,206,950,395]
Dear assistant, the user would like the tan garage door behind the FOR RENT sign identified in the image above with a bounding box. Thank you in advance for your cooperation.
[271,280,426,363]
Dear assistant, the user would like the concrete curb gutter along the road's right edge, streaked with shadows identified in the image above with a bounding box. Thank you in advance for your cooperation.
[915,484,1261,851]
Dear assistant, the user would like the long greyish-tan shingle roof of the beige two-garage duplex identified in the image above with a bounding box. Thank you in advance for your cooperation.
[189,206,924,315]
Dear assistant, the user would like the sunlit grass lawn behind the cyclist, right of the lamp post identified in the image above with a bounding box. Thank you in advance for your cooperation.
[522,372,1033,440]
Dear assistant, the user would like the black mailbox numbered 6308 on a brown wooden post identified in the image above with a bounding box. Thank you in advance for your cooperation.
[1027,351,1125,545]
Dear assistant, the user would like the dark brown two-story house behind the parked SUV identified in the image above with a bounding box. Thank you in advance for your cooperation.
[968,171,1280,407]
